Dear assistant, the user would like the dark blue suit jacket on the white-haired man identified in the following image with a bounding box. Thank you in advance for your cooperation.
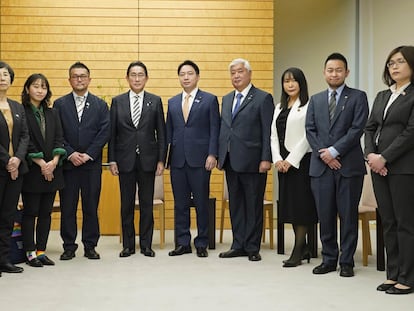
[218,86,275,173]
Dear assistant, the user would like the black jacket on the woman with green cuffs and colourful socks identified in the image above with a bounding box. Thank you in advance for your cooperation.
[23,106,63,193]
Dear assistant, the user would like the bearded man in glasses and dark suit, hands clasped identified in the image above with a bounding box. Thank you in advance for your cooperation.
[54,62,109,260]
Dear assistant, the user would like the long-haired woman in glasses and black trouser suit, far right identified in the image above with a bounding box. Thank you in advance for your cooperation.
[365,46,414,294]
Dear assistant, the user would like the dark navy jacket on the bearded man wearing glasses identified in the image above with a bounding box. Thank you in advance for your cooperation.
[54,92,110,169]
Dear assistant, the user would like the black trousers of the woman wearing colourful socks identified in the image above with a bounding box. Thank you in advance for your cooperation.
[22,191,56,252]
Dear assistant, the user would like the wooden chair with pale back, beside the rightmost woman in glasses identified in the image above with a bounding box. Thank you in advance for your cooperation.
[358,168,379,266]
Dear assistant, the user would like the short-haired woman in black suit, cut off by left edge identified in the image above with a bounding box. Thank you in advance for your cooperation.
[0,61,29,276]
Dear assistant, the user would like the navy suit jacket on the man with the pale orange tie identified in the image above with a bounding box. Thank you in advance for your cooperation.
[167,90,220,168]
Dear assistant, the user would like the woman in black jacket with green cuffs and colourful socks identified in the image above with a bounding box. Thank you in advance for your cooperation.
[22,73,66,267]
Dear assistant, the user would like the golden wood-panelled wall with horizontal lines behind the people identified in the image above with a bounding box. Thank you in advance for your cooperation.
[0,0,274,232]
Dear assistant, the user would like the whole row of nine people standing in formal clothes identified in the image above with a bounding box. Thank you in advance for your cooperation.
[0,46,414,294]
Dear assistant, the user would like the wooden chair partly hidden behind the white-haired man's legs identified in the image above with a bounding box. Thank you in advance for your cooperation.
[220,178,274,249]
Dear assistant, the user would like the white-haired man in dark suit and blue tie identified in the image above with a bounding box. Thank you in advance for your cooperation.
[218,59,274,261]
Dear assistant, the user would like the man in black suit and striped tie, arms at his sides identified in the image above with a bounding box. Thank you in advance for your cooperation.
[108,61,166,257]
